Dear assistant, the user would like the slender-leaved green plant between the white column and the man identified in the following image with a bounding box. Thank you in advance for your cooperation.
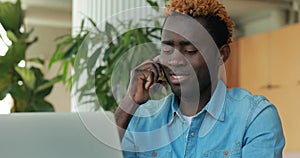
[49,0,169,111]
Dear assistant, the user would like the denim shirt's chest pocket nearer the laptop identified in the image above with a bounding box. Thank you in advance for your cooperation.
[137,148,172,158]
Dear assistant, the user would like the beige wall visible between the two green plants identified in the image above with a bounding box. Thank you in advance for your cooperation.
[27,24,71,112]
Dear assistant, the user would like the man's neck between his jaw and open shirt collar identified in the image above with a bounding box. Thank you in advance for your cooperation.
[179,82,217,116]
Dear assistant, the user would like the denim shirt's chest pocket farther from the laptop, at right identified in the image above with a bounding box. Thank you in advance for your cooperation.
[203,142,242,158]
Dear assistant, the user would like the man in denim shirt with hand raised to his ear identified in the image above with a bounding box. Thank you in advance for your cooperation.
[115,0,285,158]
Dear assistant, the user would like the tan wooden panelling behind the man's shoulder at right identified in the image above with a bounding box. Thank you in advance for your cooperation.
[235,24,300,152]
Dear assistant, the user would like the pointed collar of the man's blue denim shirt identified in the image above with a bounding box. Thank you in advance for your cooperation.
[168,80,226,124]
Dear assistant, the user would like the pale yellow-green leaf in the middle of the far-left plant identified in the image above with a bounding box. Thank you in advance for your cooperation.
[15,67,36,90]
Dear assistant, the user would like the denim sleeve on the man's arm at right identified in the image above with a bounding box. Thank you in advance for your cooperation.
[242,104,285,158]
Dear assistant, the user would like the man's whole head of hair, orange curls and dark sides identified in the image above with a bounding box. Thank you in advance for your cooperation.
[165,0,234,47]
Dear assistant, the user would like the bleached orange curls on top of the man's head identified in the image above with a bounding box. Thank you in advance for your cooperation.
[165,0,234,43]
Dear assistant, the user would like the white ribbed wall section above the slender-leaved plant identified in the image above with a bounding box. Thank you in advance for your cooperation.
[72,0,164,32]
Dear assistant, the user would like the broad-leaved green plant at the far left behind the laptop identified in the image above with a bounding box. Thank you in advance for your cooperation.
[0,0,61,112]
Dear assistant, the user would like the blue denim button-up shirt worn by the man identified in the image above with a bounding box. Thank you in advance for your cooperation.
[122,81,285,158]
